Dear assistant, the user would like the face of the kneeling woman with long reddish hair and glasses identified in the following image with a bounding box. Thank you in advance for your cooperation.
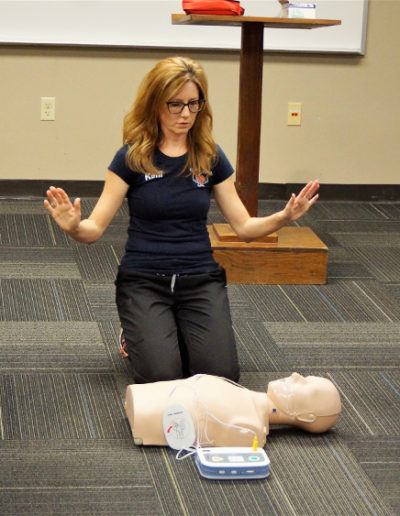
[160,81,199,139]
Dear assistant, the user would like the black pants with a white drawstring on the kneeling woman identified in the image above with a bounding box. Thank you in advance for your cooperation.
[115,268,239,383]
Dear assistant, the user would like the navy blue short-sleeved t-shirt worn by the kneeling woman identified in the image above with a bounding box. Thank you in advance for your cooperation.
[109,145,233,274]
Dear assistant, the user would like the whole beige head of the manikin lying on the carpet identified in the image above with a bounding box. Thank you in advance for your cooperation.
[267,373,341,432]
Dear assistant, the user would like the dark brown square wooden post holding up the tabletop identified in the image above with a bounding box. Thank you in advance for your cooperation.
[236,23,264,216]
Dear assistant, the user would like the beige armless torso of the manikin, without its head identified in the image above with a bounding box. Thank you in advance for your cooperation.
[125,375,269,446]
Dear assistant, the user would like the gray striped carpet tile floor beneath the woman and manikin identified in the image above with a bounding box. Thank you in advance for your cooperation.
[0,198,400,516]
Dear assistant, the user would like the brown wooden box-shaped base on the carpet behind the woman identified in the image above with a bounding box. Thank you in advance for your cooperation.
[208,224,328,285]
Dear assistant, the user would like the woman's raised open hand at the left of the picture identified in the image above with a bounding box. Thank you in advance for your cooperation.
[44,186,81,233]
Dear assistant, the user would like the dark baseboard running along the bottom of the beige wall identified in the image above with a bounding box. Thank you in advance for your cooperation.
[0,179,400,201]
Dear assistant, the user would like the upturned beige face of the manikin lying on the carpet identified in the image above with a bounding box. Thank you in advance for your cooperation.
[267,373,341,419]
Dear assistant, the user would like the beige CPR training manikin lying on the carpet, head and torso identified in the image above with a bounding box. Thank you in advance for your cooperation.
[125,373,341,447]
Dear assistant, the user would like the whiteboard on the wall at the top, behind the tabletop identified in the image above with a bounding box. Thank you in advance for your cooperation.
[0,0,368,54]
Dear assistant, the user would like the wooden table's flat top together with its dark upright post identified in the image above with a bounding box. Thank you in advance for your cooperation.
[172,14,341,216]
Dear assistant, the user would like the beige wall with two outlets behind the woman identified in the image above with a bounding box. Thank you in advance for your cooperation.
[0,0,400,184]
